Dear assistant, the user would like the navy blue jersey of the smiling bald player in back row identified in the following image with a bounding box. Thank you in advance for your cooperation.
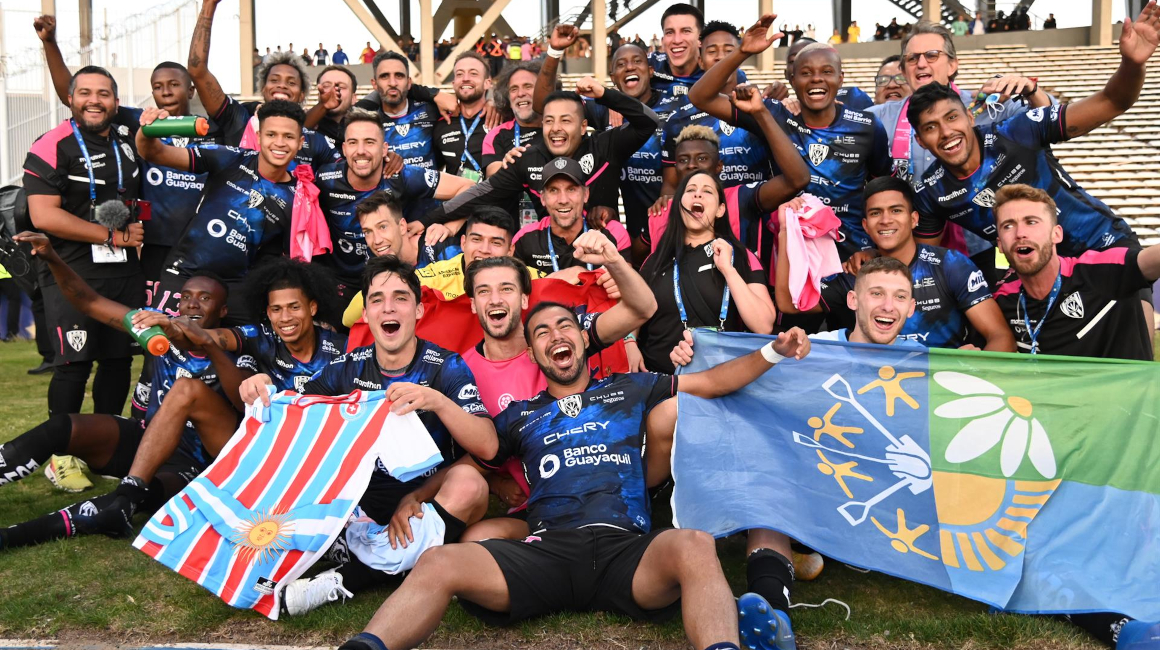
[732,100,891,258]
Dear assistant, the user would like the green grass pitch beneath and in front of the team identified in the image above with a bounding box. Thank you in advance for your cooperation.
[0,342,1099,649]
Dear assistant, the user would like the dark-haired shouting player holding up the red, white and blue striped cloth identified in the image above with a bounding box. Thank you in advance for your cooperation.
[241,255,498,615]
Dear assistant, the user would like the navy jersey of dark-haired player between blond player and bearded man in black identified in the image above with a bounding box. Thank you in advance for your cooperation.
[819,244,991,347]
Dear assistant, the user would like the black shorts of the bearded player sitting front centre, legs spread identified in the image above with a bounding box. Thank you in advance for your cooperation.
[459,526,681,626]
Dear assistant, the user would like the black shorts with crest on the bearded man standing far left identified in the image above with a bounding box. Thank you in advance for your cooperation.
[42,275,145,363]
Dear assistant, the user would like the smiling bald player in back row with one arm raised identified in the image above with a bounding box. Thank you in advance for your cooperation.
[689,15,889,259]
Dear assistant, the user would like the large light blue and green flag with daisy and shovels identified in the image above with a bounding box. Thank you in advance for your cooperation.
[673,331,1160,620]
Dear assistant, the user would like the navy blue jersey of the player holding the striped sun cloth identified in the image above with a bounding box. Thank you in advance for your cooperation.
[303,339,487,497]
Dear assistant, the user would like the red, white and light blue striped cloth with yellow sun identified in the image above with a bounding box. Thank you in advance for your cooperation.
[133,391,396,620]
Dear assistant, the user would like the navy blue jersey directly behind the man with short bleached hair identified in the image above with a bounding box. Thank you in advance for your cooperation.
[660,98,774,187]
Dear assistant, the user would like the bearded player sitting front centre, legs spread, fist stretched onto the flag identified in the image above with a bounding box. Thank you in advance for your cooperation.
[331,303,809,650]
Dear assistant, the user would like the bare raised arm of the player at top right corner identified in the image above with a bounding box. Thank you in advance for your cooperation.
[1064,0,1160,138]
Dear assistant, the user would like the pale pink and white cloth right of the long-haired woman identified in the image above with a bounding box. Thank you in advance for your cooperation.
[785,194,842,311]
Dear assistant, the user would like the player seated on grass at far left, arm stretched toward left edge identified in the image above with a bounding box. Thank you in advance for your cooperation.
[0,232,239,549]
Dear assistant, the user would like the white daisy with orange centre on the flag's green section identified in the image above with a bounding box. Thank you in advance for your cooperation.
[934,371,1056,478]
